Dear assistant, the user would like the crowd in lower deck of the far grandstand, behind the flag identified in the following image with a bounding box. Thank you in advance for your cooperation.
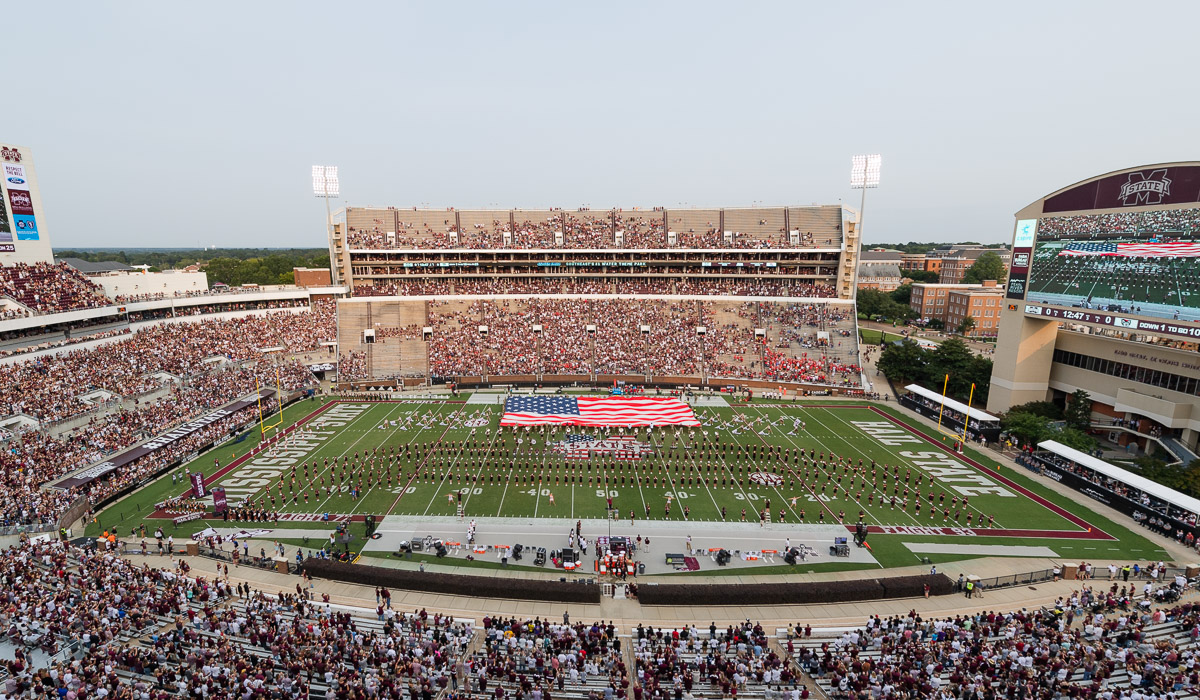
[414,299,860,385]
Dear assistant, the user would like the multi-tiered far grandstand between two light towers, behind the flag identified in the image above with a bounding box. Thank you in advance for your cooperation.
[330,207,862,389]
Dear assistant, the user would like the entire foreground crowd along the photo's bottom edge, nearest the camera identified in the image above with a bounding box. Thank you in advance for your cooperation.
[0,530,1200,700]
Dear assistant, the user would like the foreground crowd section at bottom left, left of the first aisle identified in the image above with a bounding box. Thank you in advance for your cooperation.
[0,540,474,700]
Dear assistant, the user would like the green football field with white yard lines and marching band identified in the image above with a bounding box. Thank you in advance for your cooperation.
[89,400,1165,567]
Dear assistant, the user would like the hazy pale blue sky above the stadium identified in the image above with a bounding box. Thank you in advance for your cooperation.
[0,0,1200,249]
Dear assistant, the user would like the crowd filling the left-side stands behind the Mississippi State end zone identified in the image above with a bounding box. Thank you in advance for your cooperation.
[0,303,335,526]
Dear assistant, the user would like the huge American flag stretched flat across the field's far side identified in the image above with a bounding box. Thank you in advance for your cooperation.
[500,396,700,426]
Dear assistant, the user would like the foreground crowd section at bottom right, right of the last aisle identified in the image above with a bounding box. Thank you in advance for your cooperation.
[787,581,1200,700]
